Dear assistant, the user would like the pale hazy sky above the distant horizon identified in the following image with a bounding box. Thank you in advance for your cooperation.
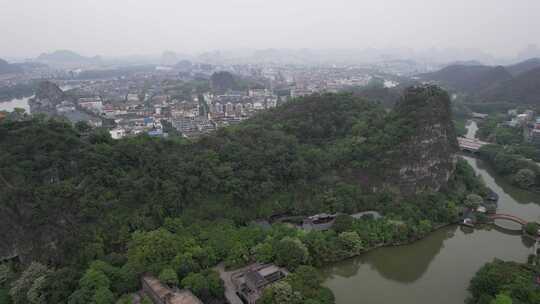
[0,0,540,57]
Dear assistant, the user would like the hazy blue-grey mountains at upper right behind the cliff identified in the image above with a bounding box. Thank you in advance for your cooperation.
[418,58,540,104]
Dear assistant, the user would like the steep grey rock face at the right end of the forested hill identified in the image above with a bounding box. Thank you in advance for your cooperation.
[390,86,459,196]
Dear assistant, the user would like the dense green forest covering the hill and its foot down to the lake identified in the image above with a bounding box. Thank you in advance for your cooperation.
[0,94,486,304]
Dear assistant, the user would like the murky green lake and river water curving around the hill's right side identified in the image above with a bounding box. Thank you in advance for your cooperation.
[324,124,540,304]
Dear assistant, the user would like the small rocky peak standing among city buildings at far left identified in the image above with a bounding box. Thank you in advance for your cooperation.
[29,81,66,115]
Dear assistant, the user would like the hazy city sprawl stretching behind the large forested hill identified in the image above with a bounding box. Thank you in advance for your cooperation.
[3,61,393,139]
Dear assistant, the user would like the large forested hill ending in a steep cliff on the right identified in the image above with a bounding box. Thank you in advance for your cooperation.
[0,87,455,264]
